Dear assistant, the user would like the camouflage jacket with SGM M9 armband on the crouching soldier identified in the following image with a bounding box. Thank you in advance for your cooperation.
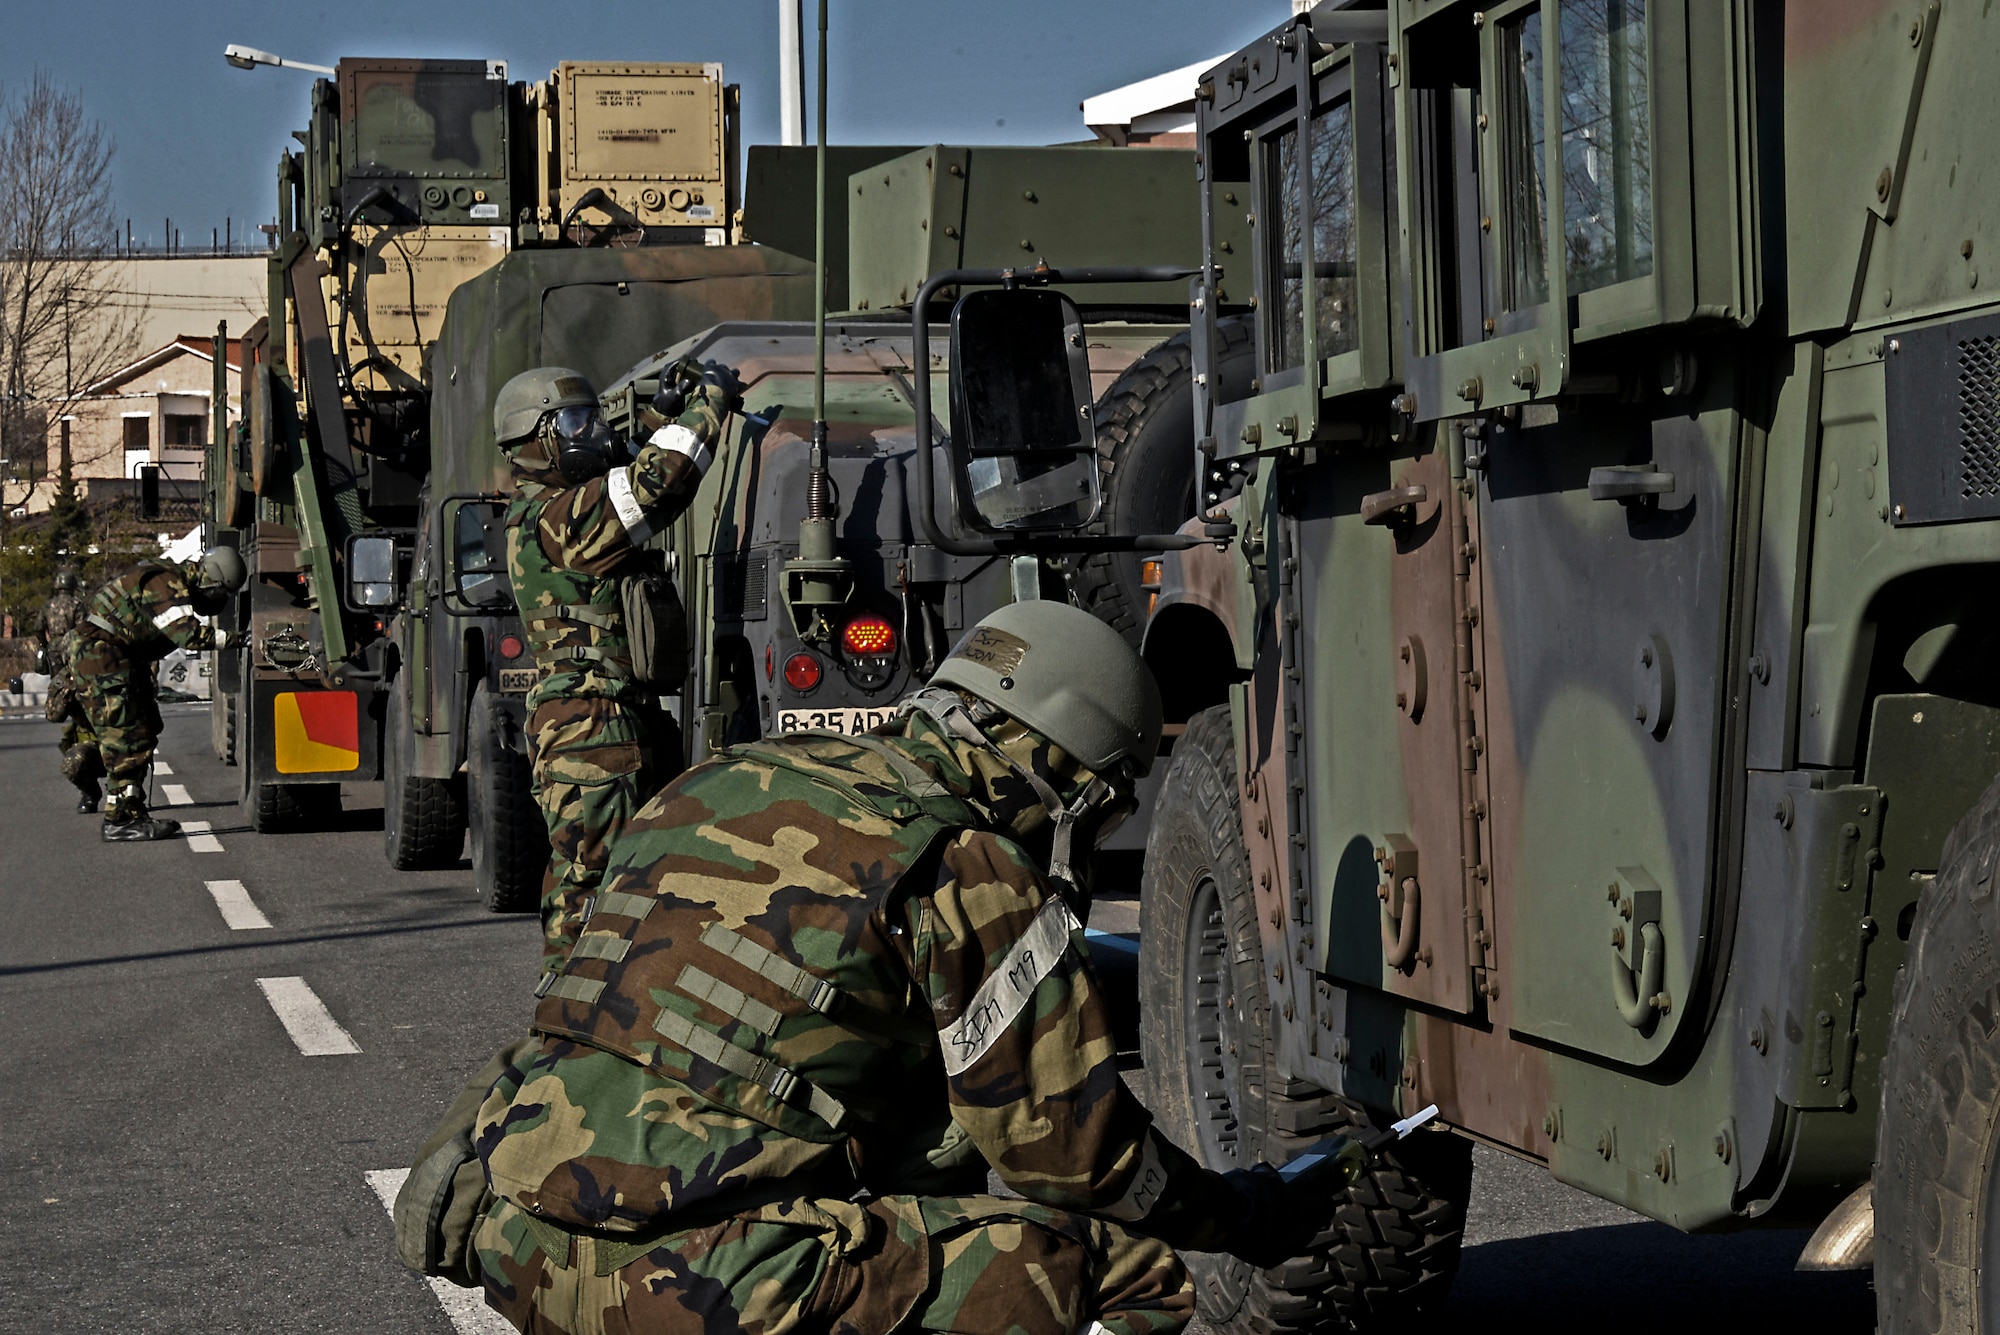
[476,719,1240,1249]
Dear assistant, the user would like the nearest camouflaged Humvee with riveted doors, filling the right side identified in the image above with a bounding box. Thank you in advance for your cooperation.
[924,0,2000,1331]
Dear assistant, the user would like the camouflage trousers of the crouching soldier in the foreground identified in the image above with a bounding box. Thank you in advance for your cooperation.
[474,1195,1194,1335]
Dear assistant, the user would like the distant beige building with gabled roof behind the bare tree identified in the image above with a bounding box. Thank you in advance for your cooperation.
[26,334,242,514]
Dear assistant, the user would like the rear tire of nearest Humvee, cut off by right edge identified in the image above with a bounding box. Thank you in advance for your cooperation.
[1874,767,2000,1335]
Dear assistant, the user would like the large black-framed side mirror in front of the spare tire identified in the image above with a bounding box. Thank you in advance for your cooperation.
[950,288,1102,532]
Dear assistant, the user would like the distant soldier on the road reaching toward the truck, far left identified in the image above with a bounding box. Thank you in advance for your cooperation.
[70,548,246,841]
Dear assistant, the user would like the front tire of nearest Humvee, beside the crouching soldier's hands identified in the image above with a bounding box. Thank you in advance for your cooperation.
[1138,705,1472,1333]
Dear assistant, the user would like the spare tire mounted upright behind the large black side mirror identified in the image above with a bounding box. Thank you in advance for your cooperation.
[1074,320,1250,648]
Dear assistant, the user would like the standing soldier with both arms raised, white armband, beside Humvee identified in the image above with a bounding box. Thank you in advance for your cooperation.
[494,359,734,967]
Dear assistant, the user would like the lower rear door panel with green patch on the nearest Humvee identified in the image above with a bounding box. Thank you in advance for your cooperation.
[1468,383,1738,1063]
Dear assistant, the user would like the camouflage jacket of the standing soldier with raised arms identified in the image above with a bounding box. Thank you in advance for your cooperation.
[506,442,702,709]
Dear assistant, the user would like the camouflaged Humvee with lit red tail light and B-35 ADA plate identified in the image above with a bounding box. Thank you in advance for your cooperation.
[576,146,1198,815]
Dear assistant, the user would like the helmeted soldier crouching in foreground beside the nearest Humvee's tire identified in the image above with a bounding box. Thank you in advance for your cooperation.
[464,604,1334,1335]
